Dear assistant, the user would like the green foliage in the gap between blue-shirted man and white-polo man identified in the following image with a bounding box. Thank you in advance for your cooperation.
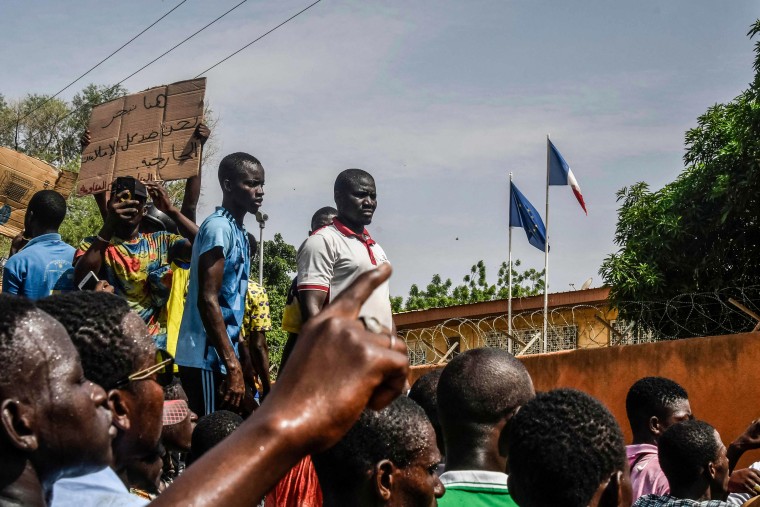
[251,233,298,374]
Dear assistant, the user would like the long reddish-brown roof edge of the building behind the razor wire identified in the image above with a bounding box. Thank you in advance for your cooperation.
[393,287,610,331]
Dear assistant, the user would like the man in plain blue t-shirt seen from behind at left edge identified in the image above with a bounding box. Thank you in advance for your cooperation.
[3,190,75,299]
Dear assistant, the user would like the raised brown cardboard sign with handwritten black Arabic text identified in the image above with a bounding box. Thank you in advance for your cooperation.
[77,78,206,195]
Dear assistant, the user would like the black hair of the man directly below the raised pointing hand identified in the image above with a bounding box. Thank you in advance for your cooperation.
[312,396,430,504]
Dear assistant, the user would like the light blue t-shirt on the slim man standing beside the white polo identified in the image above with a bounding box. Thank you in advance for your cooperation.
[176,207,251,374]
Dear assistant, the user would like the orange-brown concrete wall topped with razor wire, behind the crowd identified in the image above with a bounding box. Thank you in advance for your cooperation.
[410,333,760,466]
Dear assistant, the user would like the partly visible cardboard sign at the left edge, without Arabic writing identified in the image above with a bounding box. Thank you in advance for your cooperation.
[0,146,76,238]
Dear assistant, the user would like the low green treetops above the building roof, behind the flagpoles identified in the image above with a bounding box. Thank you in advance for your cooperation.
[391,260,544,312]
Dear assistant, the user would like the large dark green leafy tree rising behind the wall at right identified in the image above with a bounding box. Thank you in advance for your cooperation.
[599,20,760,337]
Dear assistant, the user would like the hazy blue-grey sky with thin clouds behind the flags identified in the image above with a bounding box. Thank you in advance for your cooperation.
[0,0,760,296]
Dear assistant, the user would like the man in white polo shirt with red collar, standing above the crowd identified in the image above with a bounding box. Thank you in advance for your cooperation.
[298,169,395,330]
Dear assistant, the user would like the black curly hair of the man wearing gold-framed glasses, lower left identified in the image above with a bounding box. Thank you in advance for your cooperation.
[37,291,153,389]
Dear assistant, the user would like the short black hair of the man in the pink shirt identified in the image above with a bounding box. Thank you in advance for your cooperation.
[625,377,689,434]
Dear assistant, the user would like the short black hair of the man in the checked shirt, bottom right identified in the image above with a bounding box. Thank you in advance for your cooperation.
[657,420,720,489]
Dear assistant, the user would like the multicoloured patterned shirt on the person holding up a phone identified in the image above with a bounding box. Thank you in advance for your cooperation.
[74,231,189,348]
